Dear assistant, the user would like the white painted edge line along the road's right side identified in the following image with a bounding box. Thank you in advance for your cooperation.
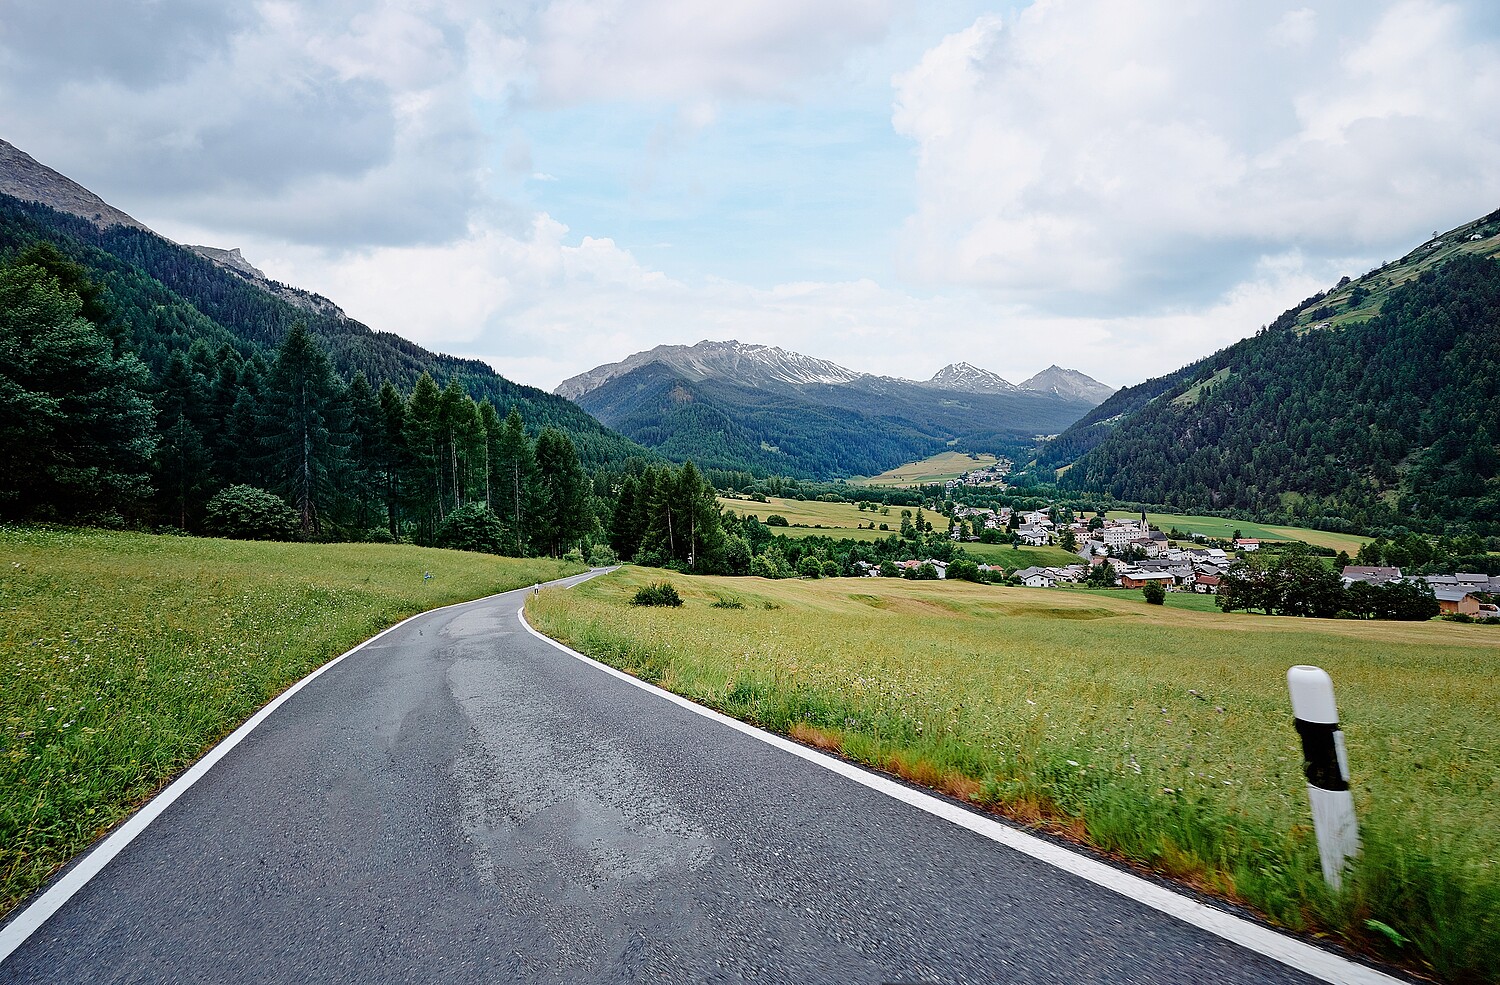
[516,606,1404,985]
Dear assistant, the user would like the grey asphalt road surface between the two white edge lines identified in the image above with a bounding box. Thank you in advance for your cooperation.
[0,572,1374,984]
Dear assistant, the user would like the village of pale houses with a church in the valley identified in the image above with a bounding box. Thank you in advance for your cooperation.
[864,507,1500,619]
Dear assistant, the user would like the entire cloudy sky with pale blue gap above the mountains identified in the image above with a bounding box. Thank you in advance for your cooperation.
[0,0,1500,388]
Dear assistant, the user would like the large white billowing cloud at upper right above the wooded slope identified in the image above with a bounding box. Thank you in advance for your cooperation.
[893,0,1500,312]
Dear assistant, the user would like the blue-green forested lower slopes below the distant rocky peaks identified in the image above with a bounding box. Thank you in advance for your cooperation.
[578,363,1089,478]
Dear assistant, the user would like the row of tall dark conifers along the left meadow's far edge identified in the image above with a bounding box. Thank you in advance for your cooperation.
[0,243,608,555]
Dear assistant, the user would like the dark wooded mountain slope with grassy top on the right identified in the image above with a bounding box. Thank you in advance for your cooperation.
[1029,211,1500,534]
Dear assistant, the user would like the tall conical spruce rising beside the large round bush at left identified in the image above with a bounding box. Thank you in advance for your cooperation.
[261,321,347,537]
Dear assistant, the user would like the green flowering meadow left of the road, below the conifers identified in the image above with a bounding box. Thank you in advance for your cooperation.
[0,526,581,916]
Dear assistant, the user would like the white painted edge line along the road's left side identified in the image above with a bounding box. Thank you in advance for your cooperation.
[0,571,603,964]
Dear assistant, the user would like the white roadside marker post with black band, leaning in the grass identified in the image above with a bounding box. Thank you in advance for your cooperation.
[1287,664,1359,889]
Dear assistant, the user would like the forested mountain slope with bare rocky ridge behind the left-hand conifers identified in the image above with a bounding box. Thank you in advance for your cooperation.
[0,141,648,465]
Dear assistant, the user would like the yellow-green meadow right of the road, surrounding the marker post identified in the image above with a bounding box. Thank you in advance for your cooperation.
[528,568,1500,981]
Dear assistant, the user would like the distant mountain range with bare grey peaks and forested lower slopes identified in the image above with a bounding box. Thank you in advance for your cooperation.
[555,340,1113,478]
